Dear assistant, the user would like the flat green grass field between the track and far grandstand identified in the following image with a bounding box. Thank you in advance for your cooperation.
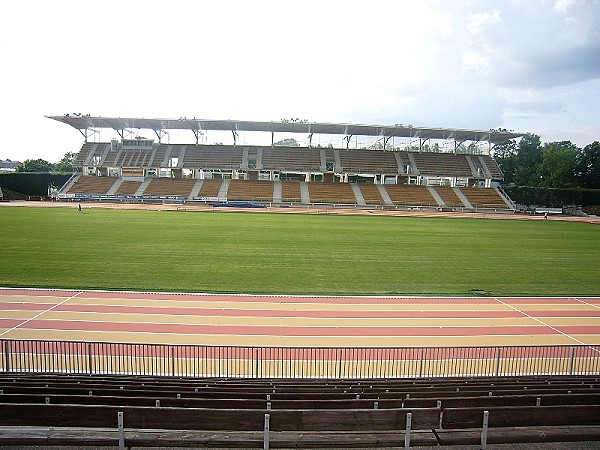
[0,207,600,295]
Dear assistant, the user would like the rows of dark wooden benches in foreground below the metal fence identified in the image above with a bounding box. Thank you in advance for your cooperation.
[0,373,600,448]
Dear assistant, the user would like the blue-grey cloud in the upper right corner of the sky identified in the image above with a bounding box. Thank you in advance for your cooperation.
[456,0,600,89]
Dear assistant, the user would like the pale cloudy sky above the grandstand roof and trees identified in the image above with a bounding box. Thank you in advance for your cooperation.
[0,0,600,162]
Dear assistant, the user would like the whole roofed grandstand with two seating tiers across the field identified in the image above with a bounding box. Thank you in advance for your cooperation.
[50,115,522,211]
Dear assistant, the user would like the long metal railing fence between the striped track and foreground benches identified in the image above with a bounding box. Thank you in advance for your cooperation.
[0,339,600,379]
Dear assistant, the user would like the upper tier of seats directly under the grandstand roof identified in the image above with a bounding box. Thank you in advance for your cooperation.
[75,142,502,180]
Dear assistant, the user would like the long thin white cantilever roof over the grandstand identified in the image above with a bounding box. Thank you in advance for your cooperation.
[46,114,524,144]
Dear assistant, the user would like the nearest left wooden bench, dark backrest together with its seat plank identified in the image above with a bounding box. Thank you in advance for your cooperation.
[0,403,441,448]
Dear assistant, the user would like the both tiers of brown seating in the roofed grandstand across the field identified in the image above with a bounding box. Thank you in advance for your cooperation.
[60,139,513,211]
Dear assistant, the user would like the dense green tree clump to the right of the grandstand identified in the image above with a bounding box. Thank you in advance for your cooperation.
[494,134,600,189]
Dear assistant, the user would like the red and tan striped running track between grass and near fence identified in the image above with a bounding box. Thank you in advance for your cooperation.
[0,288,600,347]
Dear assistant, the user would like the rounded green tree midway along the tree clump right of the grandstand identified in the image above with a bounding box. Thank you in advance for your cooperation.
[540,141,579,188]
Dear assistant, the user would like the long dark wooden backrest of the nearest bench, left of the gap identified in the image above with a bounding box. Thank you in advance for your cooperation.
[0,403,440,432]
